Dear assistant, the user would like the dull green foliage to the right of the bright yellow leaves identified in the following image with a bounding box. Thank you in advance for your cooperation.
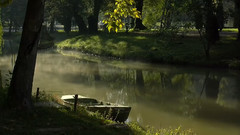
[143,0,190,29]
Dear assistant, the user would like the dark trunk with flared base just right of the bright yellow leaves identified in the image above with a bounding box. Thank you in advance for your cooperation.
[134,0,147,30]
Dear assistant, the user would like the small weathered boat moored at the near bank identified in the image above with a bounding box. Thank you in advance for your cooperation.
[61,95,131,122]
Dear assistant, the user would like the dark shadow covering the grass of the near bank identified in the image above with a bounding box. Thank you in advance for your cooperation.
[0,108,133,135]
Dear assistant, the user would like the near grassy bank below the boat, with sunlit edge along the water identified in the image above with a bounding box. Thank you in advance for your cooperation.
[0,92,195,135]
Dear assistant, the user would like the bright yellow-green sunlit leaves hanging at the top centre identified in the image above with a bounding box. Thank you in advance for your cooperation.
[103,0,140,32]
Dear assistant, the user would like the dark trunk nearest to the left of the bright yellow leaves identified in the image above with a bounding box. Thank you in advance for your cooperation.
[88,0,103,33]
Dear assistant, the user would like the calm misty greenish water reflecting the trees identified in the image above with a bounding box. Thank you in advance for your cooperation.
[0,51,240,135]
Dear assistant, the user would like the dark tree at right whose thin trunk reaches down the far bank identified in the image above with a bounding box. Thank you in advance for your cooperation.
[189,0,219,59]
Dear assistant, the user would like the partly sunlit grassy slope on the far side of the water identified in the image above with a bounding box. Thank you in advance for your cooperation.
[53,29,240,68]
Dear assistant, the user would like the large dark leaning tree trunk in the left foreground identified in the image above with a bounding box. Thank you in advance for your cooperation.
[8,0,45,110]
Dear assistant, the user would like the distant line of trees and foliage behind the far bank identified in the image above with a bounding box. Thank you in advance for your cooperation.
[2,0,240,36]
